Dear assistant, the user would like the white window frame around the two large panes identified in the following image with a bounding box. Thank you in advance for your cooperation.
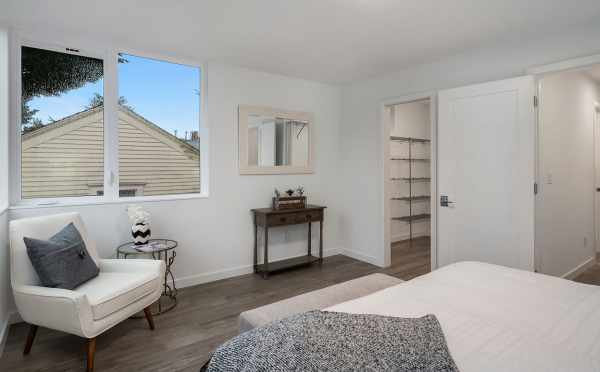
[9,34,210,209]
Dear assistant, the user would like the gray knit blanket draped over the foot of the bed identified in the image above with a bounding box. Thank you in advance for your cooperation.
[207,310,458,372]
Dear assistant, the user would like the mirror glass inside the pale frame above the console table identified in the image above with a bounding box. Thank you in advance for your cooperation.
[247,113,310,167]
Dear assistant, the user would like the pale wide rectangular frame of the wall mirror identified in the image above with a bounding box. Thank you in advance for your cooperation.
[238,105,315,174]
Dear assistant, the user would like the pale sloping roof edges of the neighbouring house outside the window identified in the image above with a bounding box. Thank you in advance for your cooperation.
[22,105,199,155]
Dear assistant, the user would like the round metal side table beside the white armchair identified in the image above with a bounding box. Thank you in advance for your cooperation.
[117,239,177,315]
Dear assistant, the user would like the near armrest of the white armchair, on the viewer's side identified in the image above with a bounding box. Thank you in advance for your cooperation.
[13,285,93,337]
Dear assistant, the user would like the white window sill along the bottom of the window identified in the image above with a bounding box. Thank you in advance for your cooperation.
[8,193,209,213]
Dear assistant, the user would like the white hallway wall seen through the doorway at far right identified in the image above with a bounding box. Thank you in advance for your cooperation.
[535,71,600,276]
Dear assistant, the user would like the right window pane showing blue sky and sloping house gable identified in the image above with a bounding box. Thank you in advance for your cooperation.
[119,54,200,196]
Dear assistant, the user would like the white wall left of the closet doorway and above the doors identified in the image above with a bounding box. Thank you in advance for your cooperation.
[340,24,600,265]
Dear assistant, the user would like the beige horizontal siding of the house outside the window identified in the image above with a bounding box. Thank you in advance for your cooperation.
[22,108,200,199]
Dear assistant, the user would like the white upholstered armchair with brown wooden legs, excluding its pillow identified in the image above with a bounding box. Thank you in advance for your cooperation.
[9,213,165,371]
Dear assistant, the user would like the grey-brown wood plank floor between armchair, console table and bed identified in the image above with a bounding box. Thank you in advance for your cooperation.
[0,239,430,372]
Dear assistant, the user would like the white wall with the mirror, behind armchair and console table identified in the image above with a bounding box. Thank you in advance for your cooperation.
[10,64,341,306]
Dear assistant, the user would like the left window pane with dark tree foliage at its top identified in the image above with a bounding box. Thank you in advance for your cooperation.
[20,47,104,199]
